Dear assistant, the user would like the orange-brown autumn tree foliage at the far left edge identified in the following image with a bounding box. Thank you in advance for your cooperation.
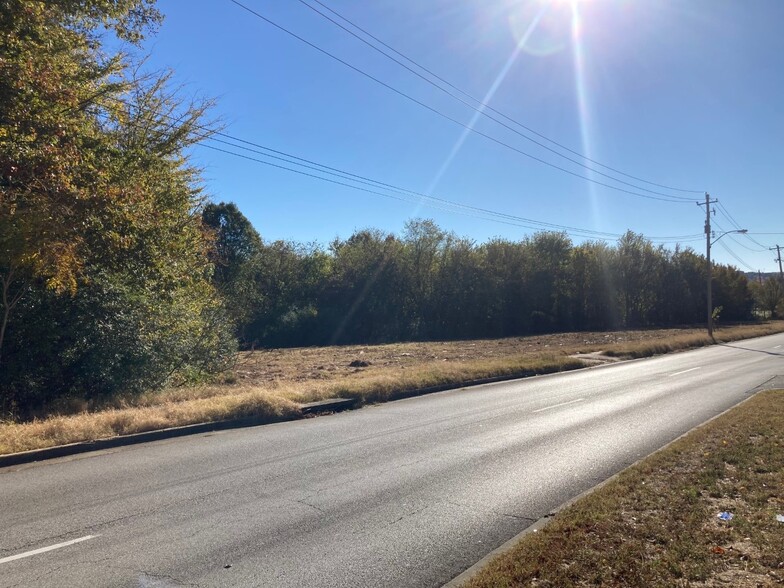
[0,0,161,361]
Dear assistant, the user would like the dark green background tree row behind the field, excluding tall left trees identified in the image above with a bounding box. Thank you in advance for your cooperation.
[205,203,754,348]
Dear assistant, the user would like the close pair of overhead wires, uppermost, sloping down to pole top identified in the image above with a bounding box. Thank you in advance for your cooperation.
[298,0,704,194]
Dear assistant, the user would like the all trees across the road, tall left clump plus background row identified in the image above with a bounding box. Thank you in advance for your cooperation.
[0,0,781,419]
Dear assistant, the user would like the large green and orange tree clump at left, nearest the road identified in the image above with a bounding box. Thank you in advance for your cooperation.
[0,0,231,413]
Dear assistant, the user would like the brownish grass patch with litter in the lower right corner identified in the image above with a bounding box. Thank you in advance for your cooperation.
[465,391,784,588]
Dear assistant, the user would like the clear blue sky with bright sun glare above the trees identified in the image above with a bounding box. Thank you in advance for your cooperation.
[139,0,784,271]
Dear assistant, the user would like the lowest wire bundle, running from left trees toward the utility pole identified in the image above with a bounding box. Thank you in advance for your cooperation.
[201,133,702,242]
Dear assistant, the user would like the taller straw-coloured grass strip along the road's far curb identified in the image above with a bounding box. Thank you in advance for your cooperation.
[0,354,583,455]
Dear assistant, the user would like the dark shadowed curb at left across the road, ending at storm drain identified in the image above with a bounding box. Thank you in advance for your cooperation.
[0,398,356,468]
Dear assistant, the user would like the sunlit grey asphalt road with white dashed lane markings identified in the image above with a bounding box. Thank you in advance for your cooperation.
[0,335,784,587]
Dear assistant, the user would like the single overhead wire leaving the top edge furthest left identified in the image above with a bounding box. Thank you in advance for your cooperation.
[229,0,694,204]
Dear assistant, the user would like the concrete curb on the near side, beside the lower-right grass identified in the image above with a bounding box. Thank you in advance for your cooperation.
[442,376,784,588]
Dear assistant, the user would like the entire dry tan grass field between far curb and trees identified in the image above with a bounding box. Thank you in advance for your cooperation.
[0,321,784,454]
